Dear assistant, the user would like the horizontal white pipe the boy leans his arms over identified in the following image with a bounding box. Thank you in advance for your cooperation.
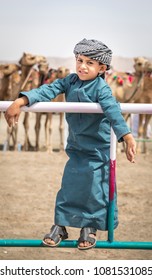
[0,101,152,114]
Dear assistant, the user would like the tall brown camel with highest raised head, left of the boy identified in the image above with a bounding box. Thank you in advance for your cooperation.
[1,53,46,151]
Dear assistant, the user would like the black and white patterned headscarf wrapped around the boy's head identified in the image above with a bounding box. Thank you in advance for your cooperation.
[73,39,112,70]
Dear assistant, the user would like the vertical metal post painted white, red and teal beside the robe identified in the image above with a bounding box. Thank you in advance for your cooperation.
[108,128,116,242]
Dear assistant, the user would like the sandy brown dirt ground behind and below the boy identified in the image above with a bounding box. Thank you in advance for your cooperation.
[0,113,152,260]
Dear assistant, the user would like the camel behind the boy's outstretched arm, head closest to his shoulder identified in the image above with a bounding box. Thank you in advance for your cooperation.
[35,65,70,152]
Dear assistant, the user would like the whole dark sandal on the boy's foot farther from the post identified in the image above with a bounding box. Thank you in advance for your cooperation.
[42,225,68,247]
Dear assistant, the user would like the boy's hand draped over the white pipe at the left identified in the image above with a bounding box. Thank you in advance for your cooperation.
[4,97,28,127]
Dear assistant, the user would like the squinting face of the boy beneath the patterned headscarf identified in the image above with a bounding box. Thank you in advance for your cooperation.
[76,55,107,81]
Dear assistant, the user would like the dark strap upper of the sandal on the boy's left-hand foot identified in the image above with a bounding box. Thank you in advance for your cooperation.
[44,225,68,243]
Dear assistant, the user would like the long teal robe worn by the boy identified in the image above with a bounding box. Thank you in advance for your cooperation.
[20,74,130,230]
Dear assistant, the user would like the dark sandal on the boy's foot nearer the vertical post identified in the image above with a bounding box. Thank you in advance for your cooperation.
[78,227,97,250]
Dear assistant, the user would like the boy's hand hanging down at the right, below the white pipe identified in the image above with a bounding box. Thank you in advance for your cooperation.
[123,133,136,163]
